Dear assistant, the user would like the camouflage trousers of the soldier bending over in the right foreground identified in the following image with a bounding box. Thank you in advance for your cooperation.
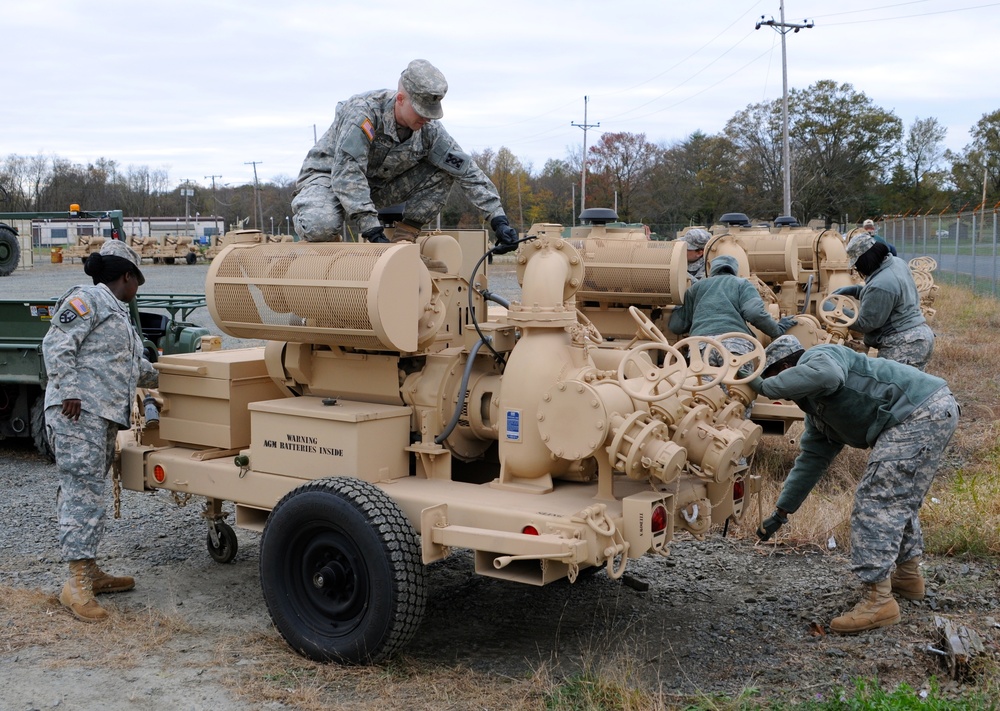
[851,387,959,583]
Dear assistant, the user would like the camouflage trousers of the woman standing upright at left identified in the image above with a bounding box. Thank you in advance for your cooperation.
[45,405,119,561]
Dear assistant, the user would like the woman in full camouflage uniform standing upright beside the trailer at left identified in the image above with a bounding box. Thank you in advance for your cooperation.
[42,240,157,622]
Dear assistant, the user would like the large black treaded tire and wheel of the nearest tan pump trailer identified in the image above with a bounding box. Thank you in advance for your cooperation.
[260,477,426,664]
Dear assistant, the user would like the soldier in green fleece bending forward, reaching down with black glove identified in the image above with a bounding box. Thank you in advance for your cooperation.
[751,335,959,634]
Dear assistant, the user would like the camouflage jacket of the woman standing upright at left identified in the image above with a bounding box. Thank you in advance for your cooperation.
[42,284,158,427]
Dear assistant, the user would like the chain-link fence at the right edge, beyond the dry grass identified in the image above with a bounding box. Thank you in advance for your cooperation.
[879,211,1000,298]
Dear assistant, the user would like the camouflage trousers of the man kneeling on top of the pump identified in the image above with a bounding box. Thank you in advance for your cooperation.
[292,163,455,242]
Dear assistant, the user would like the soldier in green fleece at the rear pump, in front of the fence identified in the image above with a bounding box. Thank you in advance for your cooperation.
[833,232,934,370]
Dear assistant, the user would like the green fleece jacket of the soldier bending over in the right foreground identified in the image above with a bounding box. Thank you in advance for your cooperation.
[751,345,947,512]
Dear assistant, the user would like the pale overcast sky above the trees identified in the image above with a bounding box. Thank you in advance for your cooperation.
[7,0,1000,192]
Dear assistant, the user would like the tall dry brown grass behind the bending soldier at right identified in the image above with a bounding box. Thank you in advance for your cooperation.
[735,285,1000,555]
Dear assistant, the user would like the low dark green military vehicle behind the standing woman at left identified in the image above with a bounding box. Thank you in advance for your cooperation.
[0,294,214,457]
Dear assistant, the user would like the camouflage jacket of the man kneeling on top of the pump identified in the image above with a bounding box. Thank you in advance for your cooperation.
[295,89,504,232]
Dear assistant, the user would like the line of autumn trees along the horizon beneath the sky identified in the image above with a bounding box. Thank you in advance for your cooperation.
[0,80,1000,234]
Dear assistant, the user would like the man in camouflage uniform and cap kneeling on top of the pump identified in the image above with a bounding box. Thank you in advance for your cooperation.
[292,59,517,262]
